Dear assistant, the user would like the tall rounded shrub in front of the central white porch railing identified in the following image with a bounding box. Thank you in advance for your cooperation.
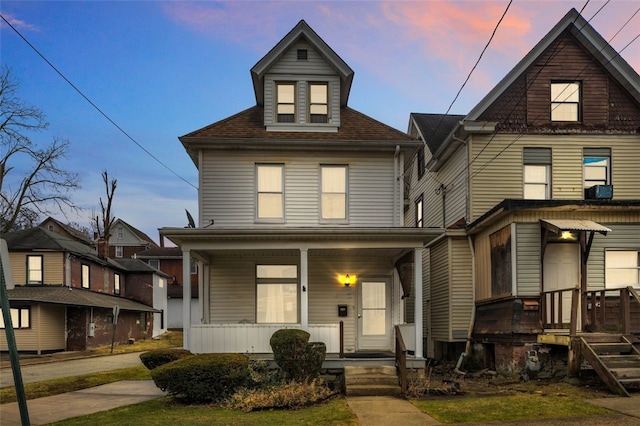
[269,329,327,382]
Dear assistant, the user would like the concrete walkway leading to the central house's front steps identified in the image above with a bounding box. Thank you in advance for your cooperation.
[347,396,440,426]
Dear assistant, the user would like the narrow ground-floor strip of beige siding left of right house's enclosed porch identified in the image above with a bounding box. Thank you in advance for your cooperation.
[450,238,474,341]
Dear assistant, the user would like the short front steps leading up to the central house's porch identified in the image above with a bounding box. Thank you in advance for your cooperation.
[344,365,402,396]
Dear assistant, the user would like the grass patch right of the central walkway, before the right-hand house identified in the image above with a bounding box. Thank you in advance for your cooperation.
[412,394,609,423]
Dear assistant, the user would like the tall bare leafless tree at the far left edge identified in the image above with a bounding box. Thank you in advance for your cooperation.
[0,67,80,233]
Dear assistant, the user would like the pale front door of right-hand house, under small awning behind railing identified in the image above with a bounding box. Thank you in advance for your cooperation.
[543,244,581,329]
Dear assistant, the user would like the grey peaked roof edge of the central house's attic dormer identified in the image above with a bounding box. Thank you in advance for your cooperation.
[251,19,354,106]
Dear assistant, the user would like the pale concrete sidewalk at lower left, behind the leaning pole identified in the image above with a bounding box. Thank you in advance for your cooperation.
[0,380,166,426]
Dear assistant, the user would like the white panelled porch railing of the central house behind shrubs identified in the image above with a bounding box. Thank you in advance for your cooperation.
[189,324,340,353]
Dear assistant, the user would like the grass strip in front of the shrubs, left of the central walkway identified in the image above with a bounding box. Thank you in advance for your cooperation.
[52,397,359,426]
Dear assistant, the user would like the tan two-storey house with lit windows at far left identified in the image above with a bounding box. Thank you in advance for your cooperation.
[0,227,159,353]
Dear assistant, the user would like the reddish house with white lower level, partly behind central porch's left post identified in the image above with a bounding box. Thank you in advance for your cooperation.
[134,247,200,329]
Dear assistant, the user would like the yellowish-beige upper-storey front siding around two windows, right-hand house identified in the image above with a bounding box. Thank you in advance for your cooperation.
[471,134,640,220]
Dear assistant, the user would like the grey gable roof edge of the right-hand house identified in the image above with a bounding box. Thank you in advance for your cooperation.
[465,9,640,120]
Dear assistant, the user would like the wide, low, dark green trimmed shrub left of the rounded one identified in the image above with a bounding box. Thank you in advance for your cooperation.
[151,353,249,402]
